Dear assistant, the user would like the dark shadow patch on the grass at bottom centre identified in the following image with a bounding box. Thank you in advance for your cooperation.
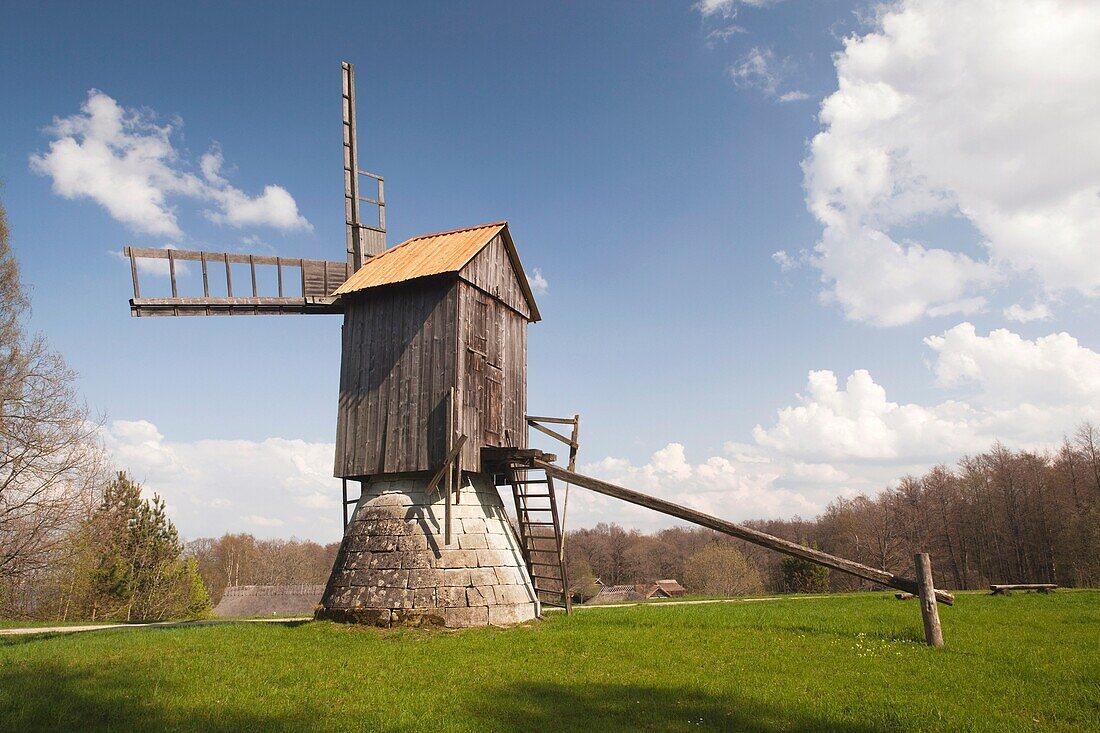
[470,682,888,733]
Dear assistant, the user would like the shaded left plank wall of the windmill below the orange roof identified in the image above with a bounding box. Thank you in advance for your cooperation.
[334,280,459,478]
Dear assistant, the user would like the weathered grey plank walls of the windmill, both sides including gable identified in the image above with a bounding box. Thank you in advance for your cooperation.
[336,231,530,478]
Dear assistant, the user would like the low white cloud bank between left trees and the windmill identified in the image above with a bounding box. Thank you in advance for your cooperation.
[102,420,341,541]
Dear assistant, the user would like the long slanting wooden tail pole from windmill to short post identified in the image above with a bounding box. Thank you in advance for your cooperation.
[534,459,955,605]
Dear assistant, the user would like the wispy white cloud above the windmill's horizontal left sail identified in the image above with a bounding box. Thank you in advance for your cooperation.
[30,89,311,239]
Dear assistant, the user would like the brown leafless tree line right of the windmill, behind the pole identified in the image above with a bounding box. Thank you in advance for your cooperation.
[565,431,1100,597]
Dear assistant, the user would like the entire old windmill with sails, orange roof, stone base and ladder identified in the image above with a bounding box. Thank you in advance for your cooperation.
[125,64,568,626]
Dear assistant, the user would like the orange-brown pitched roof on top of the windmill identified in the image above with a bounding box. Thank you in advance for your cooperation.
[332,221,540,320]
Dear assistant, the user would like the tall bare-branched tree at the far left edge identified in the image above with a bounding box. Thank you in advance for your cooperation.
[0,197,101,614]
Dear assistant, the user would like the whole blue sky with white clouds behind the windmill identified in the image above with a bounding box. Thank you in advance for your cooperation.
[0,0,1100,538]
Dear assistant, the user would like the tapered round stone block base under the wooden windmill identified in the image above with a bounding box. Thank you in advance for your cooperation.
[315,473,539,627]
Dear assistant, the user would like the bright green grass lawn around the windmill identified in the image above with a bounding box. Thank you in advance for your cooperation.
[0,591,1100,733]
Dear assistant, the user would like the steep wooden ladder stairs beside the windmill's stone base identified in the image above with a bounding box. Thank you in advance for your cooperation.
[506,460,573,613]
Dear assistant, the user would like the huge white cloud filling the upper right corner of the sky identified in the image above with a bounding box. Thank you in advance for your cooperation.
[803,0,1100,326]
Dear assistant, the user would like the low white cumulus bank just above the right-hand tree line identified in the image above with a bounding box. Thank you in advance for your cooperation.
[571,322,1100,528]
